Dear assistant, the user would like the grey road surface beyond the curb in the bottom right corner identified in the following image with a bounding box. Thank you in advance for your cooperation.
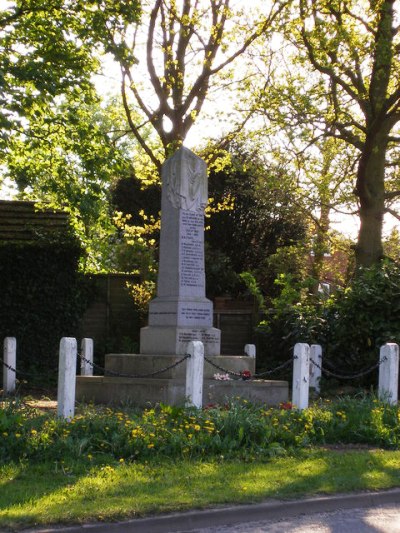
[187,504,400,533]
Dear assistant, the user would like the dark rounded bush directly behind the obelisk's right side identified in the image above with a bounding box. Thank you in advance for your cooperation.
[205,143,307,298]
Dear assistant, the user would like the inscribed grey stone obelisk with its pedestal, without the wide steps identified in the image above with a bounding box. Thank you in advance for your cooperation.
[140,147,221,356]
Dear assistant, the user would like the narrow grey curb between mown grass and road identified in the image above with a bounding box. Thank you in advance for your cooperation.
[25,489,400,533]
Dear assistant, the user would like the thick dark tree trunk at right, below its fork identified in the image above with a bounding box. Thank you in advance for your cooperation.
[355,133,387,268]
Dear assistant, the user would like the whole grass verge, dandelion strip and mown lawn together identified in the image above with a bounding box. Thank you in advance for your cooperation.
[0,394,400,529]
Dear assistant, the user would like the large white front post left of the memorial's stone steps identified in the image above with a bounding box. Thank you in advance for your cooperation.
[57,337,77,420]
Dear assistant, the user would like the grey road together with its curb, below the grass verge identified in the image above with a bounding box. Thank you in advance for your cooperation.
[25,488,400,533]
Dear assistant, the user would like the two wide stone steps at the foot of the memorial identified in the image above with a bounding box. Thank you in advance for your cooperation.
[76,354,289,407]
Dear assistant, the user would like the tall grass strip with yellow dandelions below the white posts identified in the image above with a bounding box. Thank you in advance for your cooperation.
[0,396,400,464]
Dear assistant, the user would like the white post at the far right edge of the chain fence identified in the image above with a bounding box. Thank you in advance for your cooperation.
[378,342,399,404]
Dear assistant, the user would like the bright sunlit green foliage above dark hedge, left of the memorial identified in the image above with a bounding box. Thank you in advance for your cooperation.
[4,94,138,271]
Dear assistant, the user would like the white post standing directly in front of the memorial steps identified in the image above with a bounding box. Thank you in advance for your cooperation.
[186,341,204,409]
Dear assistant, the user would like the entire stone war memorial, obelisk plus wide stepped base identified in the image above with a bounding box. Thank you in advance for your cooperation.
[77,147,288,405]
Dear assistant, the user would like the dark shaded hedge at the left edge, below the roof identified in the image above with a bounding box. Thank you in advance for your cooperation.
[0,232,91,383]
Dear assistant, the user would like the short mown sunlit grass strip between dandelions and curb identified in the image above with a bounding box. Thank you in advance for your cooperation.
[0,448,400,529]
